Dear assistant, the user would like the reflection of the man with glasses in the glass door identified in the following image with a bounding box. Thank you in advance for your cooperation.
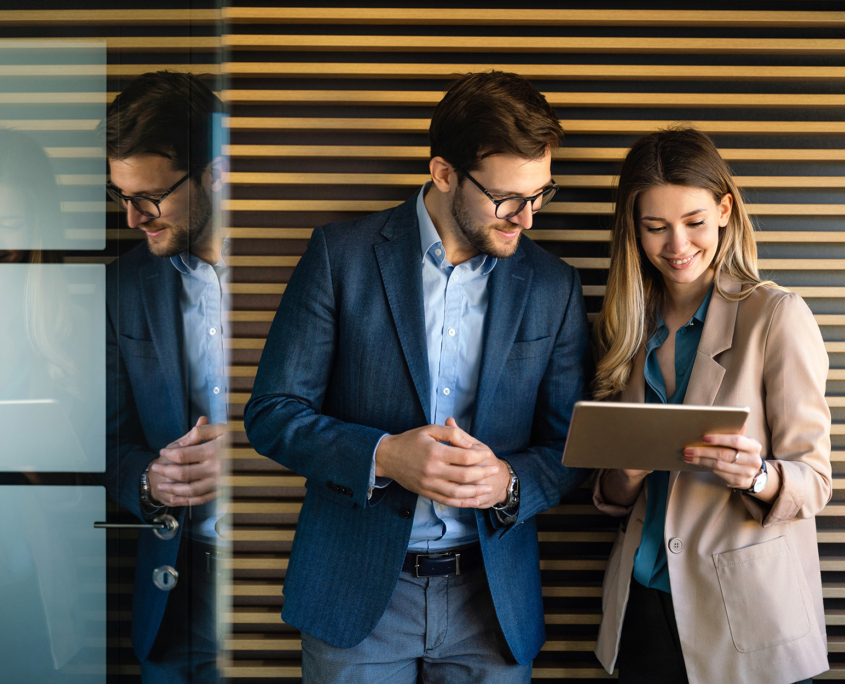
[103,72,228,684]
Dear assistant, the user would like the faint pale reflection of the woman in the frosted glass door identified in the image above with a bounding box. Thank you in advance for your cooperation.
[0,129,90,682]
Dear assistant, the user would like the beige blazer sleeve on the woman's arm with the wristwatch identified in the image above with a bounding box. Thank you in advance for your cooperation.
[742,294,832,527]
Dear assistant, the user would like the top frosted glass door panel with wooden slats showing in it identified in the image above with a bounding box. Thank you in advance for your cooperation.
[0,40,106,251]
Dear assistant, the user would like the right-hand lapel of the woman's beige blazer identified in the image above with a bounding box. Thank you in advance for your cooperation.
[667,276,742,494]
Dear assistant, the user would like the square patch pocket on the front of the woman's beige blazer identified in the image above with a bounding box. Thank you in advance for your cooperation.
[713,536,810,653]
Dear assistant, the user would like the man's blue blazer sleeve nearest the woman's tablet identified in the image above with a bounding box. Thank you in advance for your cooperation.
[491,262,592,529]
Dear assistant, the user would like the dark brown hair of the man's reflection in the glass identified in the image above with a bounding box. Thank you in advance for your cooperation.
[100,71,223,172]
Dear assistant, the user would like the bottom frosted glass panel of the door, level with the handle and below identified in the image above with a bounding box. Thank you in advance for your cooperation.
[0,484,106,684]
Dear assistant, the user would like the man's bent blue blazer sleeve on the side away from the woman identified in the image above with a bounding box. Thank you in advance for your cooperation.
[244,227,386,507]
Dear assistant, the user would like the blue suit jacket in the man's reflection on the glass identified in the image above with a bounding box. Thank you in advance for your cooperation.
[106,242,190,661]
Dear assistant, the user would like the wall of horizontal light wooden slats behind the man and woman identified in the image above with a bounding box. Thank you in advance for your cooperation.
[0,1,845,683]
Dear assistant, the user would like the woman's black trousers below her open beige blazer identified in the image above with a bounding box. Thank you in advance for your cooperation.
[616,577,813,684]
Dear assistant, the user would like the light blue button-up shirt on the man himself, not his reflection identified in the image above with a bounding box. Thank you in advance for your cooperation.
[370,181,497,551]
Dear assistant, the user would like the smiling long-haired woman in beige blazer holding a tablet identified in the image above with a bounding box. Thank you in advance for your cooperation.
[593,129,831,684]
